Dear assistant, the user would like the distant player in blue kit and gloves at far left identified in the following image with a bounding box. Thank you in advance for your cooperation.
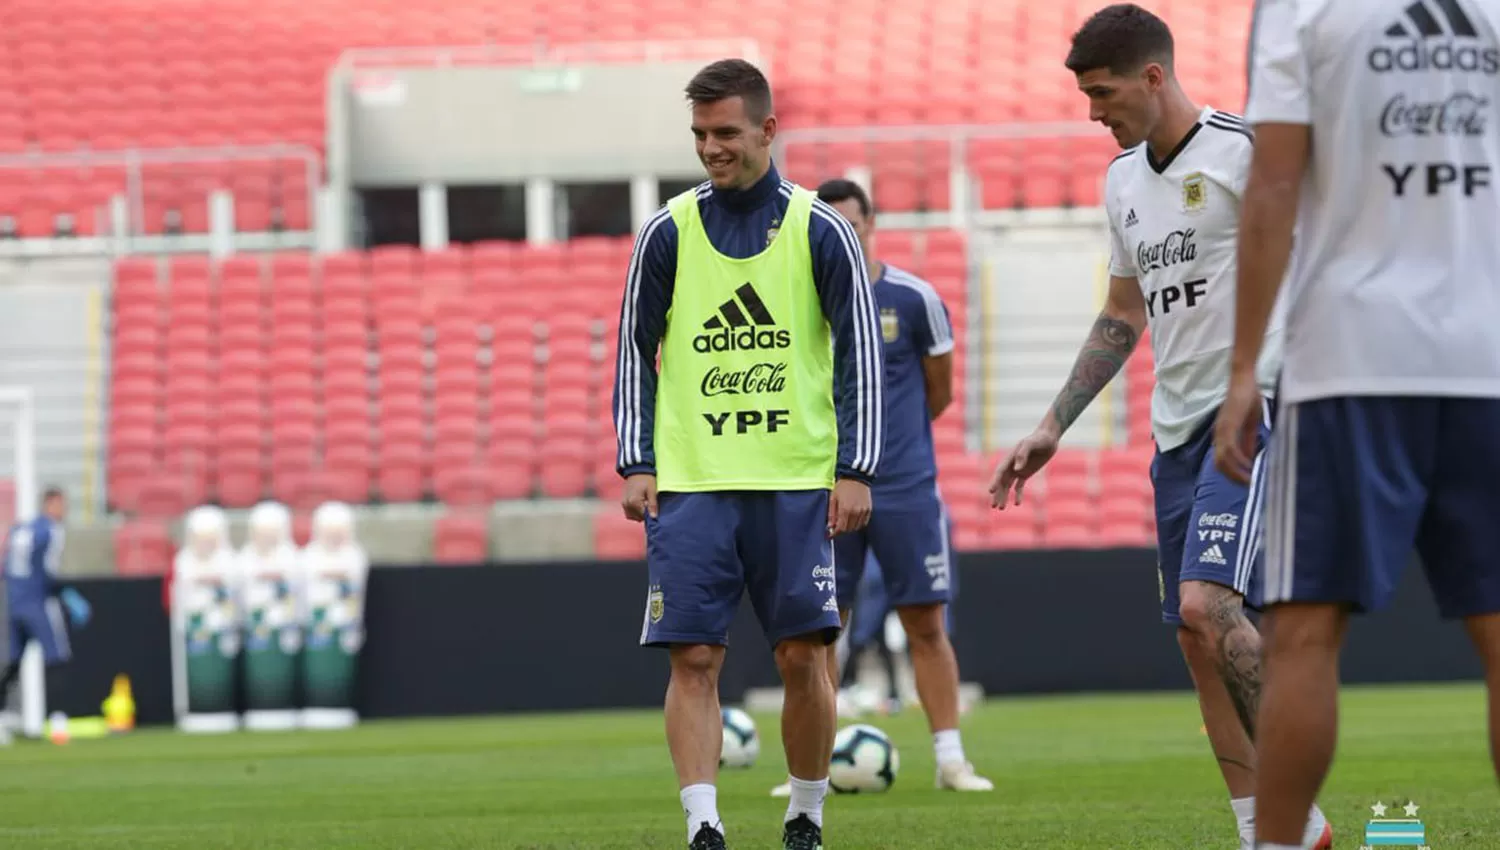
[0,489,92,734]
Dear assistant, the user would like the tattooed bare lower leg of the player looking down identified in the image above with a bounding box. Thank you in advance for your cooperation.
[1178,582,1260,798]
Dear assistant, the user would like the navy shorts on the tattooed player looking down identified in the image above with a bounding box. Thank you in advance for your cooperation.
[1151,402,1272,624]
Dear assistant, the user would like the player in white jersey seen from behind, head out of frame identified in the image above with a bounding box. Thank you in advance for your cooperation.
[1215,0,1500,849]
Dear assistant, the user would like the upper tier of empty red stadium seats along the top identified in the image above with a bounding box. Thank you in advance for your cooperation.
[0,0,1250,237]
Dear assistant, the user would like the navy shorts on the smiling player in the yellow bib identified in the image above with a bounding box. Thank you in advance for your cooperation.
[641,490,839,646]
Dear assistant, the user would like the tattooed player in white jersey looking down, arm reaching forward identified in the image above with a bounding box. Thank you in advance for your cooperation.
[990,4,1332,847]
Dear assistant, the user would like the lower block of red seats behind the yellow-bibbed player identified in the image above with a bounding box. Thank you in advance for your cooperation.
[107,231,966,516]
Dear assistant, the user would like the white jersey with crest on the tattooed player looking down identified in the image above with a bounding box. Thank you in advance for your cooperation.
[1104,108,1281,451]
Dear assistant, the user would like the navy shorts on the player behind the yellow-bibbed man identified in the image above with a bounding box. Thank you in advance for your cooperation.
[834,493,953,610]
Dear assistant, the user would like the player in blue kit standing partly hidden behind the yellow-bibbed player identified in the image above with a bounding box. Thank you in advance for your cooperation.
[771,180,995,795]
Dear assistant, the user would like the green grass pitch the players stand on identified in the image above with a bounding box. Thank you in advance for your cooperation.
[0,685,1500,850]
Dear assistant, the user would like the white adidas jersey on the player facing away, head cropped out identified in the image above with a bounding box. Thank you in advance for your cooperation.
[1248,0,1500,402]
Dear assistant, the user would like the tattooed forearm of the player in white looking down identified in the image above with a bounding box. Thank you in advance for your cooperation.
[1041,274,1146,438]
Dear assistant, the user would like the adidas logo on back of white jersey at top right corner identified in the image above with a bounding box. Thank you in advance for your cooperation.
[1368,0,1500,75]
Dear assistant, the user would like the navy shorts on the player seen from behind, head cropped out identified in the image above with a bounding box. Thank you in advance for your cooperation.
[1263,396,1500,618]
